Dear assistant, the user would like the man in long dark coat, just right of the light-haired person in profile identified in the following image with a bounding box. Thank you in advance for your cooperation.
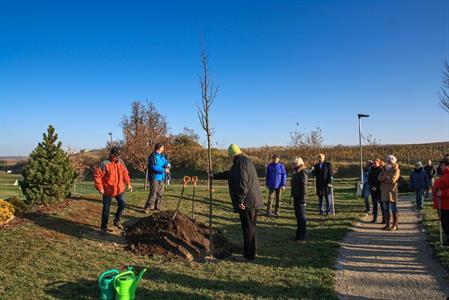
[312,153,333,215]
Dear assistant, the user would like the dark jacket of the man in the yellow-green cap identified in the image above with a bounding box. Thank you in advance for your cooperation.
[228,155,263,213]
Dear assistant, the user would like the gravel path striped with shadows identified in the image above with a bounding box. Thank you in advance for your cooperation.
[335,197,449,299]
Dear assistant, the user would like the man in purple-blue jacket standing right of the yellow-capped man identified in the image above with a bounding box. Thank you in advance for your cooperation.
[265,154,287,216]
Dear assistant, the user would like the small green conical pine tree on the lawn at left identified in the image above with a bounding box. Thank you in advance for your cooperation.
[20,125,76,205]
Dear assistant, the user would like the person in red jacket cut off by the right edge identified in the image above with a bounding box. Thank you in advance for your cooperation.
[432,158,449,246]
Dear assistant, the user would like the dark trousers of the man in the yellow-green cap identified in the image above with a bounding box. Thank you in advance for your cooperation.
[239,209,257,260]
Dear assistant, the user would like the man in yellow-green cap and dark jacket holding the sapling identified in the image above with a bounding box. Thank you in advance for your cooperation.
[228,144,263,260]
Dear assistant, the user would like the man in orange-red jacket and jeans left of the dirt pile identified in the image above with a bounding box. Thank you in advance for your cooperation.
[94,147,133,235]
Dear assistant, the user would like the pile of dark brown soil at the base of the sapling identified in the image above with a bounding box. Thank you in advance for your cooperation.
[126,211,240,260]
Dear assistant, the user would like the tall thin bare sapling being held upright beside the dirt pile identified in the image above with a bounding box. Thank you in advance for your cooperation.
[197,46,218,257]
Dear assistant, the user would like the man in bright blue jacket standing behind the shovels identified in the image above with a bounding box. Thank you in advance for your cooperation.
[145,143,170,214]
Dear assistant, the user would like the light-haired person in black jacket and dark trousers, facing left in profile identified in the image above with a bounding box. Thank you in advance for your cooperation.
[291,157,307,244]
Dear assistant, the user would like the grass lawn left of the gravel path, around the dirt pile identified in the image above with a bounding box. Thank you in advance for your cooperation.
[0,176,364,299]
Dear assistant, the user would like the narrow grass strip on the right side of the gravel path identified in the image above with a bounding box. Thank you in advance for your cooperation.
[422,199,449,272]
